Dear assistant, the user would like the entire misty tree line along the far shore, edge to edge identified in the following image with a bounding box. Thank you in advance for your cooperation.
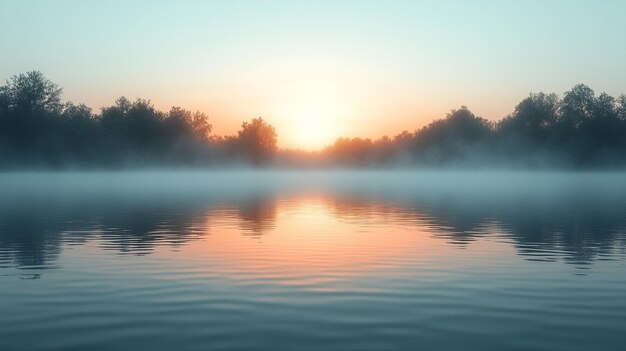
[0,71,626,169]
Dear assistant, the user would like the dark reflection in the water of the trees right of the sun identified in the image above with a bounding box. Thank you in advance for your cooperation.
[332,196,626,264]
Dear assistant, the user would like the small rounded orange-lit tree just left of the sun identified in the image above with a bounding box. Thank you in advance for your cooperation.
[237,117,277,166]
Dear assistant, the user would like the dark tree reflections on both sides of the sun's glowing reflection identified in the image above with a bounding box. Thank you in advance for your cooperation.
[0,184,626,278]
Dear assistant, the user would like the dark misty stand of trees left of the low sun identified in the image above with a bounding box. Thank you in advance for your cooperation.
[0,71,276,168]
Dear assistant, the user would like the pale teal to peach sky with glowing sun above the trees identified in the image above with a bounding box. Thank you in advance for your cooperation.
[0,0,626,150]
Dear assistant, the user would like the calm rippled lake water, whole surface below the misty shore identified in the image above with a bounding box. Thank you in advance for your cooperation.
[0,172,626,351]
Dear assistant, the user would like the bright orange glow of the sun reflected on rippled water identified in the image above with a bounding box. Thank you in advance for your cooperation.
[163,194,511,289]
